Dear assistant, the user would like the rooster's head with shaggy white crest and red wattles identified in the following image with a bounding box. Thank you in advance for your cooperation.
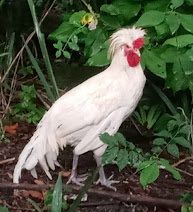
[109,27,145,67]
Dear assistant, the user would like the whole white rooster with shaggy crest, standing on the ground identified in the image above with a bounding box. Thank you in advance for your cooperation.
[13,27,146,188]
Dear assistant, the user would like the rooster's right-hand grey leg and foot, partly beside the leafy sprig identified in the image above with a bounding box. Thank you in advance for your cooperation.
[94,155,119,191]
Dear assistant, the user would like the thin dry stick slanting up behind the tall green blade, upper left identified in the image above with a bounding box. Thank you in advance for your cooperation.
[0,0,56,84]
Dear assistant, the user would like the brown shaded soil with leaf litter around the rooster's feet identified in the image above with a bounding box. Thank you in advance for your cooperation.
[0,121,193,212]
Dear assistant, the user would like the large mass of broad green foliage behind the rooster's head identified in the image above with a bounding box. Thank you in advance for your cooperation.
[49,0,193,100]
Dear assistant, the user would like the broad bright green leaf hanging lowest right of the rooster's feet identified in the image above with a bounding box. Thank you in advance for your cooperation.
[140,162,159,188]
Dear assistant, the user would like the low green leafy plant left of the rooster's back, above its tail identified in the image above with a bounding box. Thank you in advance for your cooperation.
[13,85,45,124]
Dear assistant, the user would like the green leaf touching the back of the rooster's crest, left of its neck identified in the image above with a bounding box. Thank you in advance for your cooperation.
[86,49,109,67]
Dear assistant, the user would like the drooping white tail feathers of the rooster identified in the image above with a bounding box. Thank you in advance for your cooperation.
[13,126,59,183]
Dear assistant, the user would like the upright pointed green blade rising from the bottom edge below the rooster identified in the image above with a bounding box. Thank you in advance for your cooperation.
[51,174,62,212]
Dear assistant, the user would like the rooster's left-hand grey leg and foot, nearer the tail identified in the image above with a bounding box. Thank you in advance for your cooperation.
[67,154,87,186]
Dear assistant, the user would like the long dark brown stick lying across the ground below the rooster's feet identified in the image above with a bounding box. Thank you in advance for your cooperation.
[0,183,182,209]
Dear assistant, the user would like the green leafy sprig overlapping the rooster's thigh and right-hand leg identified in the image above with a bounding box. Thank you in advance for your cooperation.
[100,133,144,171]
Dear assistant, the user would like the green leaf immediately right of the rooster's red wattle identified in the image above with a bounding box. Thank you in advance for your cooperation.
[142,49,166,79]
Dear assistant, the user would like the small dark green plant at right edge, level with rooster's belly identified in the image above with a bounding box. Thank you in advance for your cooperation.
[152,113,192,158]
